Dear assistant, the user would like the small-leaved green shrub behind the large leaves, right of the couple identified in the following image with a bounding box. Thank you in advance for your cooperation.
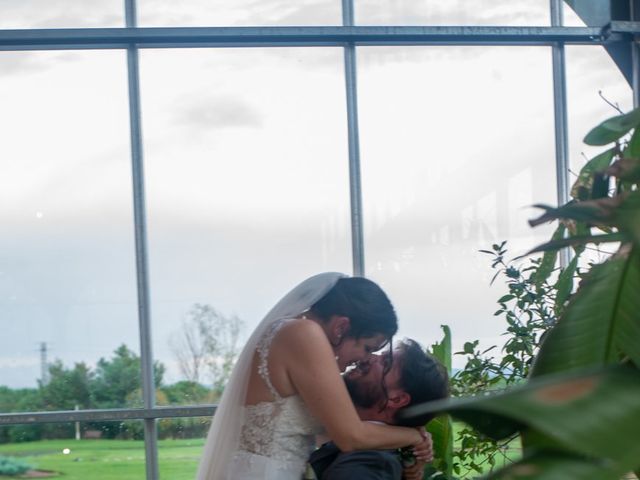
[434,241,566,478]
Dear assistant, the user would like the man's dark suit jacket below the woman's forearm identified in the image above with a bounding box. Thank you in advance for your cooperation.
[309,442,402,480]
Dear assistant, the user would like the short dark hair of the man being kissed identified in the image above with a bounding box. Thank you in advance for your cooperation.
[394,338,449,427]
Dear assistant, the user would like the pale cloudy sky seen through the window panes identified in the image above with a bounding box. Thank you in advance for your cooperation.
[0,0,631,396]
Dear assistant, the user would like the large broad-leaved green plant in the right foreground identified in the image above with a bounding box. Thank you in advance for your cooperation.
[408,105,640,480]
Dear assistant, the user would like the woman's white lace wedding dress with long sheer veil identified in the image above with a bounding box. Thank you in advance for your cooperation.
[197,273,345,480]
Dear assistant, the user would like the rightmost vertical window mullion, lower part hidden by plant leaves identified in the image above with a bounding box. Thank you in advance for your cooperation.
[550,0,570,268]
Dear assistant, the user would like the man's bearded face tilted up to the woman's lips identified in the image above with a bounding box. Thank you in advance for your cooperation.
[344,349,402,408]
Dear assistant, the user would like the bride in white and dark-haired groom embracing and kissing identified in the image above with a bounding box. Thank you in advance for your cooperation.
[197,273,447,480]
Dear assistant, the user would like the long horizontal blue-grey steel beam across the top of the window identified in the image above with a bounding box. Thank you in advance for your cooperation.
[0,26,615,50]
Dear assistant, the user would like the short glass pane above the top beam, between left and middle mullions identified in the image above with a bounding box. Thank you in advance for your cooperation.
[138,0,342,26]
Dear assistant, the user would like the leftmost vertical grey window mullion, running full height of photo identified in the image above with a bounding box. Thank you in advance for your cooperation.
[125,0,159,480]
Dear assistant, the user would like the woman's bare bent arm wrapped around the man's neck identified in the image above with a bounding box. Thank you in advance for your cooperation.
[278,322,423,452]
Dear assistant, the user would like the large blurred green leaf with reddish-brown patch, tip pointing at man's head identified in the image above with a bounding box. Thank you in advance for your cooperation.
[404,365,640,470]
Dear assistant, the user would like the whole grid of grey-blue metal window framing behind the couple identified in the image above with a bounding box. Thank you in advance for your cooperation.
[0,0,640,480]
